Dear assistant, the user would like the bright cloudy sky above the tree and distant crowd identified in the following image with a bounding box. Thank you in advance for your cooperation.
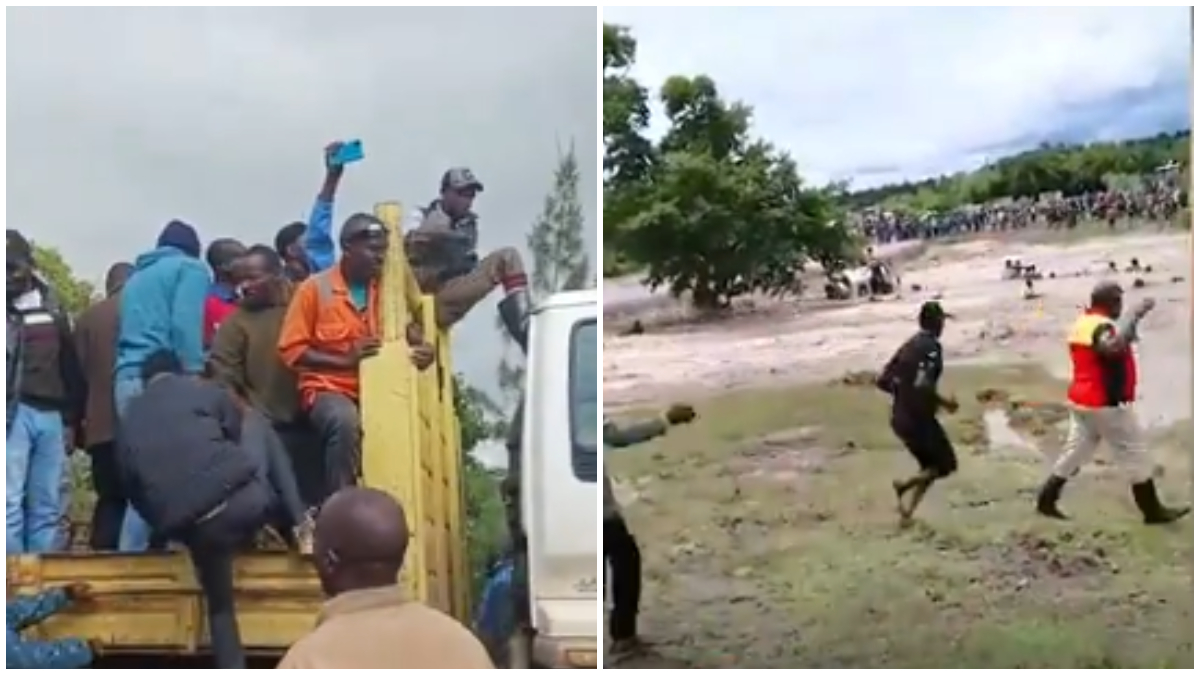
[604,7,1192,186]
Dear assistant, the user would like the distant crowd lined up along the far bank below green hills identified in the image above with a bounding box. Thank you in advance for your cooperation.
[853,181,1187,244]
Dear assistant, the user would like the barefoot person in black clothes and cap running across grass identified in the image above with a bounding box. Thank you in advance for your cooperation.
[876,301,959,526]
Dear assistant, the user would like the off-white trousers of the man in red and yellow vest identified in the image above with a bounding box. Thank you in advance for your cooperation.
[1052,406,1154,483]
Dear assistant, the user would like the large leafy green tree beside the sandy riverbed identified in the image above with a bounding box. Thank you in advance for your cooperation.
[602,25,851,309]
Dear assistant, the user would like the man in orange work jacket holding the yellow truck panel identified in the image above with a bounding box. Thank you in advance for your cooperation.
[280,214,434,495]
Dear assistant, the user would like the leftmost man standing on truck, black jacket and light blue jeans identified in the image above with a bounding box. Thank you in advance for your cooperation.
[5,229,85,555]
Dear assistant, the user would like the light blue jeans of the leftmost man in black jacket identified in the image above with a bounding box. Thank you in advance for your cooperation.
[5,405,67,555]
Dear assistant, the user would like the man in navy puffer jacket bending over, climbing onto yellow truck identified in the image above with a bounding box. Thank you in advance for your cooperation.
[116,352,271,668]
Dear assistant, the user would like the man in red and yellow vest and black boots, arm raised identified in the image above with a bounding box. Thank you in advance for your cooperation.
[1038,281,1192,525]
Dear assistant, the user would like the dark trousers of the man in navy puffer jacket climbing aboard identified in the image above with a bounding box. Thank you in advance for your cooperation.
[179,480,270,668]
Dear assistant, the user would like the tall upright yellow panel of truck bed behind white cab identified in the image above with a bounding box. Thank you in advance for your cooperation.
[361,202,470,620]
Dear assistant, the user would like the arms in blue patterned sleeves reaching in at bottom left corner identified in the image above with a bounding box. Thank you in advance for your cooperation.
[4,584,97,670]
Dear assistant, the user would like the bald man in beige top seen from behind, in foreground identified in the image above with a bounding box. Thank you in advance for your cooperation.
[278,488,494,670]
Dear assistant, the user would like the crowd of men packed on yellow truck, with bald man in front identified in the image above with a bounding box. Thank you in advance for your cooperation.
[5,144,520,668]
